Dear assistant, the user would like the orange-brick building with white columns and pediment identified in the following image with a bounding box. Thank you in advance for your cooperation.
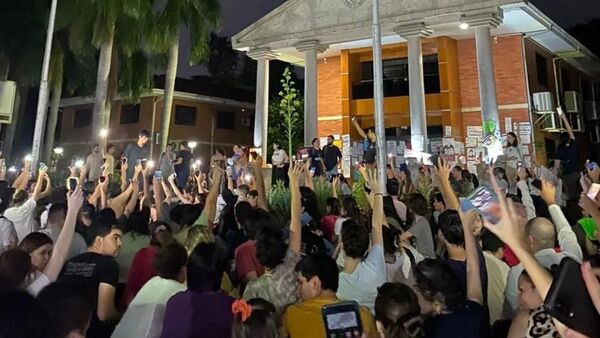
[232,0,600,163]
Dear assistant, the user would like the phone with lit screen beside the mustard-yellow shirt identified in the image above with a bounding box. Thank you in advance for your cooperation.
[321,301,363,338]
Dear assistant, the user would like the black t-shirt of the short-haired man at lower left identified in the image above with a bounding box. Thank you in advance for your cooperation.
[58,252,119,338]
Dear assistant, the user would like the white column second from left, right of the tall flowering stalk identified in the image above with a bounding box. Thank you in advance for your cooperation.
[294,40,326,145]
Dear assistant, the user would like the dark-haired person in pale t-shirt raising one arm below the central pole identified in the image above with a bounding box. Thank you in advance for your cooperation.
[337,170,387,312]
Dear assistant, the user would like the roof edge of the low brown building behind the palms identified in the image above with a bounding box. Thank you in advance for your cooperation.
[60,88,254,110]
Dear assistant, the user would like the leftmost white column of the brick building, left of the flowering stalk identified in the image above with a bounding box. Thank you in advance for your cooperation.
[248,48,273,156]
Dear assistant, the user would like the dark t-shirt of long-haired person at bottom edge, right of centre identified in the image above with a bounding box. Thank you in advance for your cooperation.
[424,300,489,338]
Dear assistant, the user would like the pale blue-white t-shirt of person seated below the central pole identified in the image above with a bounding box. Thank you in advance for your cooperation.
[336,244,387,313]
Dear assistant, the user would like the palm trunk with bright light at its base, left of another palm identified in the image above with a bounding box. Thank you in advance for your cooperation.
[92,25,115,144]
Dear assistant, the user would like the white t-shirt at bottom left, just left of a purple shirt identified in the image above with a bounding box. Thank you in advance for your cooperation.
[111,276,186,338]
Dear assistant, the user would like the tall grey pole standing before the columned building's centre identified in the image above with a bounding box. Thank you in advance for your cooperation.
[342,0,387,187]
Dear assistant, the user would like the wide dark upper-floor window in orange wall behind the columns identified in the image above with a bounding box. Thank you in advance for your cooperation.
[352,55,440,99]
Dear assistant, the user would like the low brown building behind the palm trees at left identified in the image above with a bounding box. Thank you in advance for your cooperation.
[56,89,254,164]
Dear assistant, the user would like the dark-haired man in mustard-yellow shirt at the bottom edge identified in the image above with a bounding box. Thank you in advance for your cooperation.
[281,255,378,338]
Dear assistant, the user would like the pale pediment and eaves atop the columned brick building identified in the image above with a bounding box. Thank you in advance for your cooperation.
[232,0,600,76]
